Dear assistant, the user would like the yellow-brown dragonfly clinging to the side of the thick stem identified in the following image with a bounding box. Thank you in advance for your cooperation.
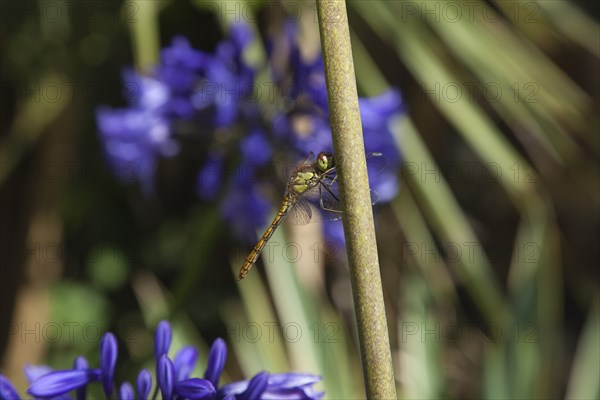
[238,152,383,280]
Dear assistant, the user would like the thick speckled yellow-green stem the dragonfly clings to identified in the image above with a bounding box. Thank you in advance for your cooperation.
[317,0,396,400]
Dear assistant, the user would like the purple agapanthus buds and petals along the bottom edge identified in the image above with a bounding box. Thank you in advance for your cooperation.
[0,321,323,400]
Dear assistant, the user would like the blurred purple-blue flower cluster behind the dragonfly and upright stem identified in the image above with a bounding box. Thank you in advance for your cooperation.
[97,23,404,244]
